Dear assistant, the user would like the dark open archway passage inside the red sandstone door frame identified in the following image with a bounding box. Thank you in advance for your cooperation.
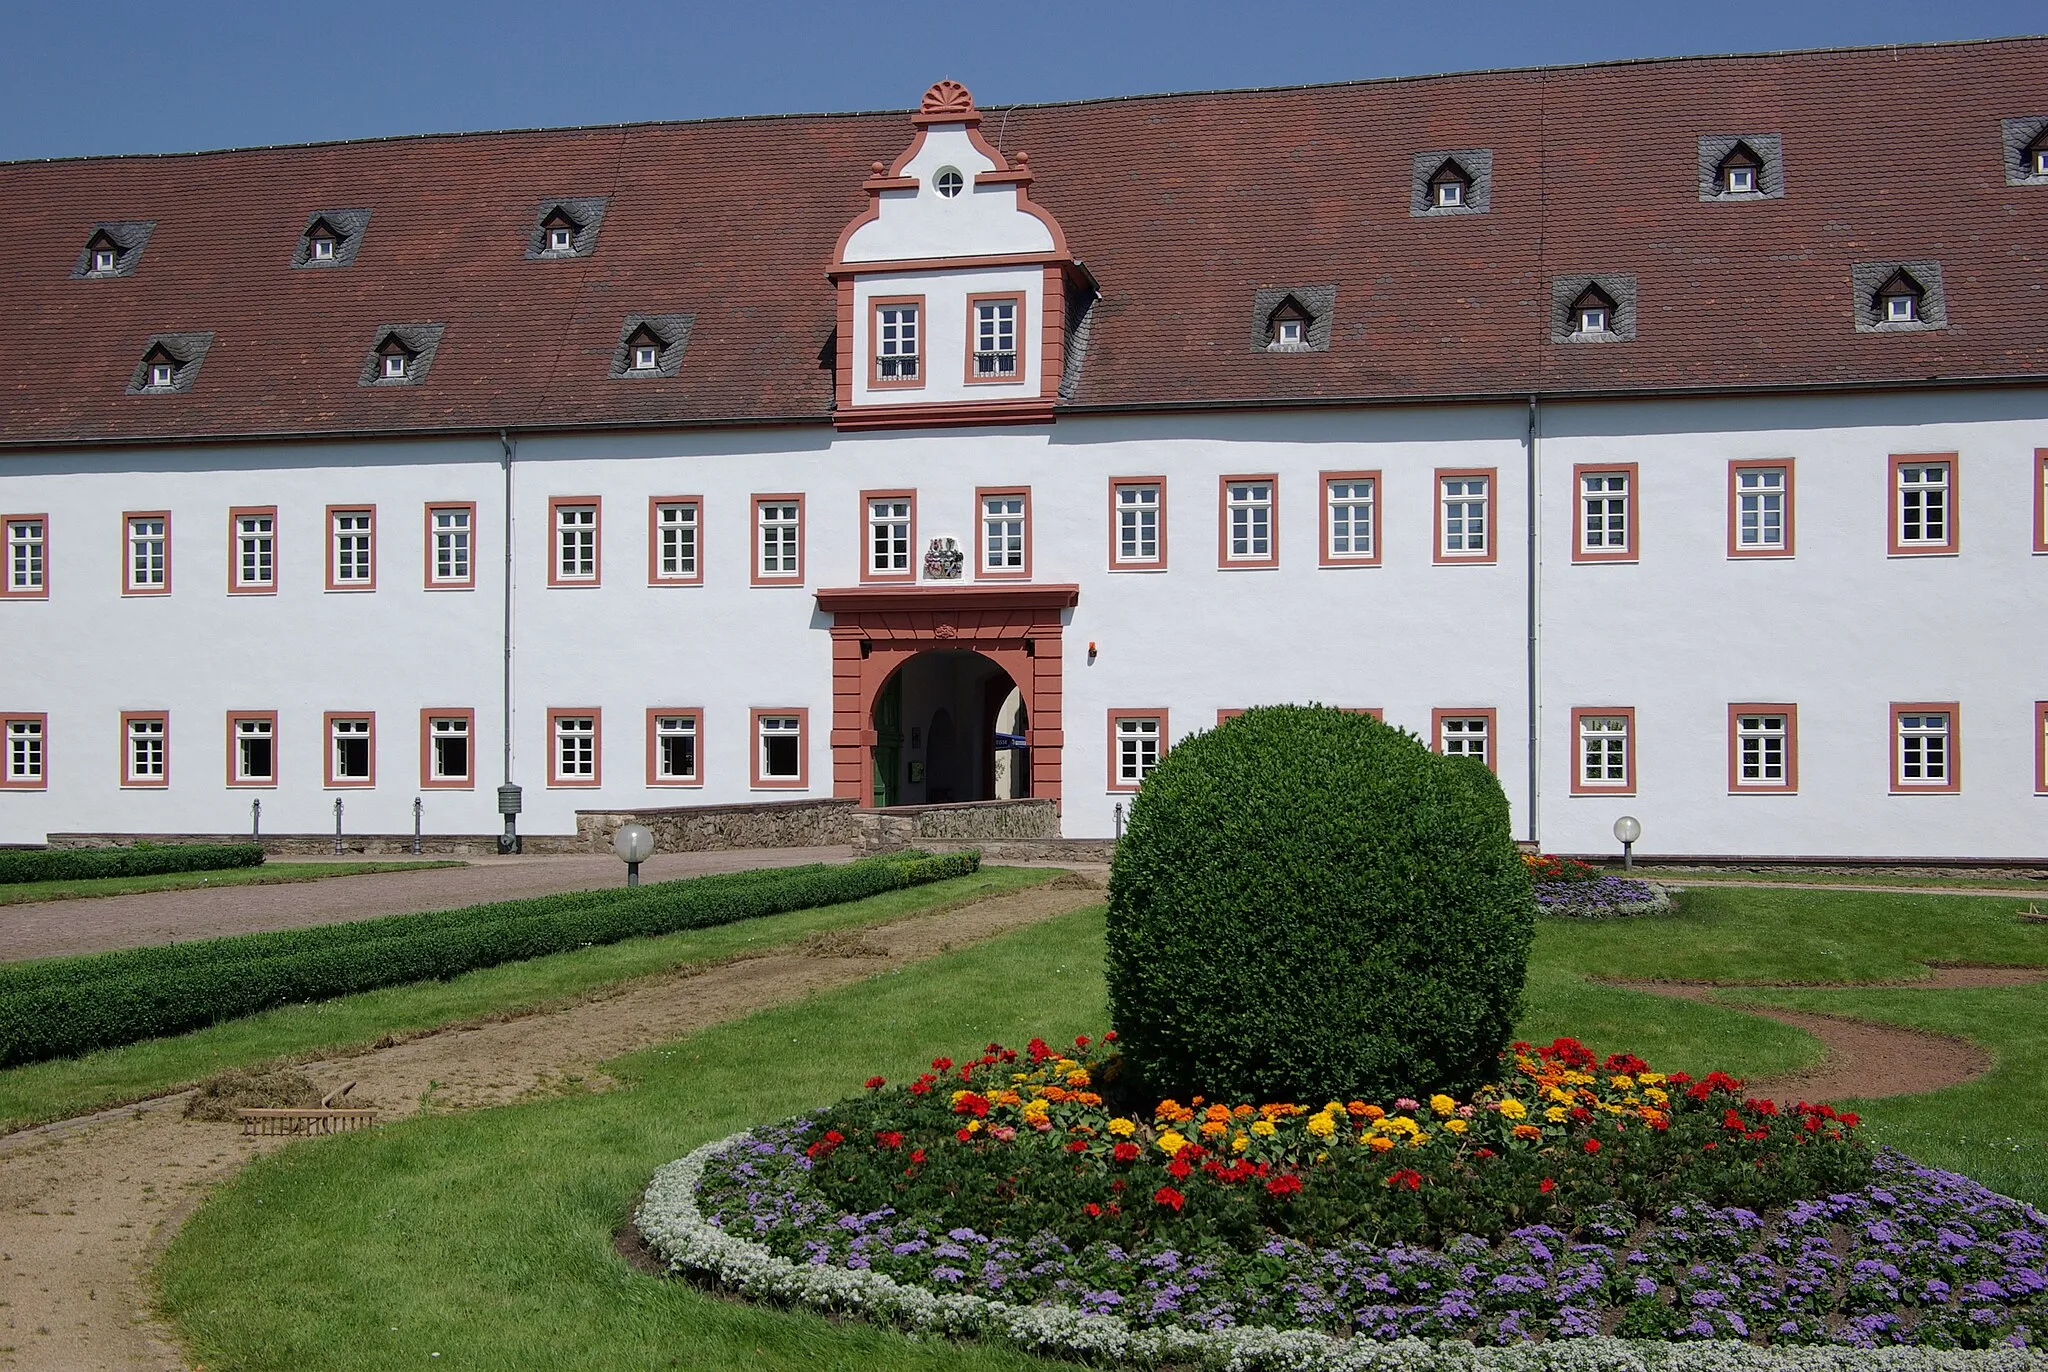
[868,649,1030,805]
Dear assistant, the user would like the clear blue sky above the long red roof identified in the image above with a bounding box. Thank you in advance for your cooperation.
[0,0,2048,160]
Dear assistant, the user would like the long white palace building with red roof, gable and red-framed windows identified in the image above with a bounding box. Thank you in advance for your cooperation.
[0,39,2048,860]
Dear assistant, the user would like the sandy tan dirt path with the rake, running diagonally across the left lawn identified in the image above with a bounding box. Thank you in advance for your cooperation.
[0,878,1102,1372]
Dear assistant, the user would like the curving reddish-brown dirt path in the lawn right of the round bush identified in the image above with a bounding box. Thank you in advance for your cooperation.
[1608,967,2048,1104]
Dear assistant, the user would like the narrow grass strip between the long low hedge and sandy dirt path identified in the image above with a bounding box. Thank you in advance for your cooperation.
[0,866,1059,1132]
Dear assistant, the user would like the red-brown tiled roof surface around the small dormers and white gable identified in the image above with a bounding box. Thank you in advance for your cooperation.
[0,39,2048,446]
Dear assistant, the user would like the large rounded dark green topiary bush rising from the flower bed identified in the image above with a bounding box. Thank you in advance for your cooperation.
[1108,706,1536,1104]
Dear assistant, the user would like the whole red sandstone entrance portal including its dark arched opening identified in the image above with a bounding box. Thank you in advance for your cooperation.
[817,586,1081,805]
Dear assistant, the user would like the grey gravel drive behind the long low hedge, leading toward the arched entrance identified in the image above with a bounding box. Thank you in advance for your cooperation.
[0,848,854,962]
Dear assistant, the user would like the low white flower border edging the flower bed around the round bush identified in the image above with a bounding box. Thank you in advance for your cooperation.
[633,1130,2048,1372]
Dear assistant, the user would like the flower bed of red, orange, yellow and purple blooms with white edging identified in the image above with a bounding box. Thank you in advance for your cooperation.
[641,1040,2048,1368]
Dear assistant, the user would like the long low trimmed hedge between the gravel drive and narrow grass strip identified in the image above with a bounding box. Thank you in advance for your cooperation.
[0,852,981,1067]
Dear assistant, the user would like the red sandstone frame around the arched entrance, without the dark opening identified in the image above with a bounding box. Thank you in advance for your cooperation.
[817,586,1081,805]
